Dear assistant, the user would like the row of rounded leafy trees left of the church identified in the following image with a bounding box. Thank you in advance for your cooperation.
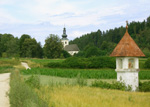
[0,34,69,58]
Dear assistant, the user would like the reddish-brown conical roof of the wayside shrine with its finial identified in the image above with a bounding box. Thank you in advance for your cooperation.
[110,20,145,57]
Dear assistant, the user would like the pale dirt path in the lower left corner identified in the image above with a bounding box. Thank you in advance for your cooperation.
[0,73,10,107]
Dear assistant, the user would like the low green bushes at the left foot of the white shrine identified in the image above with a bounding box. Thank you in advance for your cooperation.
[92,80,131,91]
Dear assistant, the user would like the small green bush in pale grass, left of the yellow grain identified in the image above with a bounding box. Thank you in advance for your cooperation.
[25,75,40,89]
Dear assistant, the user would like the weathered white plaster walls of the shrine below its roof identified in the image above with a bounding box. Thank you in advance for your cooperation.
[116,57,139,91]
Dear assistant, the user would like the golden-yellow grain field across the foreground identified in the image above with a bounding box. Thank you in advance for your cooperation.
[37,86,150,107]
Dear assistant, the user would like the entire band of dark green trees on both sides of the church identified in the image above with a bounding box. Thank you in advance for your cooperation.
[0,16,150,58]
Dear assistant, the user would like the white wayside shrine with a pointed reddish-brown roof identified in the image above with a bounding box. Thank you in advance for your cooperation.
[110,22,145,91]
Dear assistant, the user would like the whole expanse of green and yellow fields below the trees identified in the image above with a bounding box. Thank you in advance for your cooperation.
[0,59,150,107]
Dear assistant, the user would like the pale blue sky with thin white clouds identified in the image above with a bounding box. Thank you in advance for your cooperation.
[0,0,150,45]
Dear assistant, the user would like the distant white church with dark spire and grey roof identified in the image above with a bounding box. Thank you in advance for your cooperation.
[61,27,80,55]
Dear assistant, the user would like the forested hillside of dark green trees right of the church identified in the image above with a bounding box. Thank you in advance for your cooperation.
[70,16,150,57]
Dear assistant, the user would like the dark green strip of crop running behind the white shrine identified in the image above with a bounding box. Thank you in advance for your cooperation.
[21,68,150,80]
